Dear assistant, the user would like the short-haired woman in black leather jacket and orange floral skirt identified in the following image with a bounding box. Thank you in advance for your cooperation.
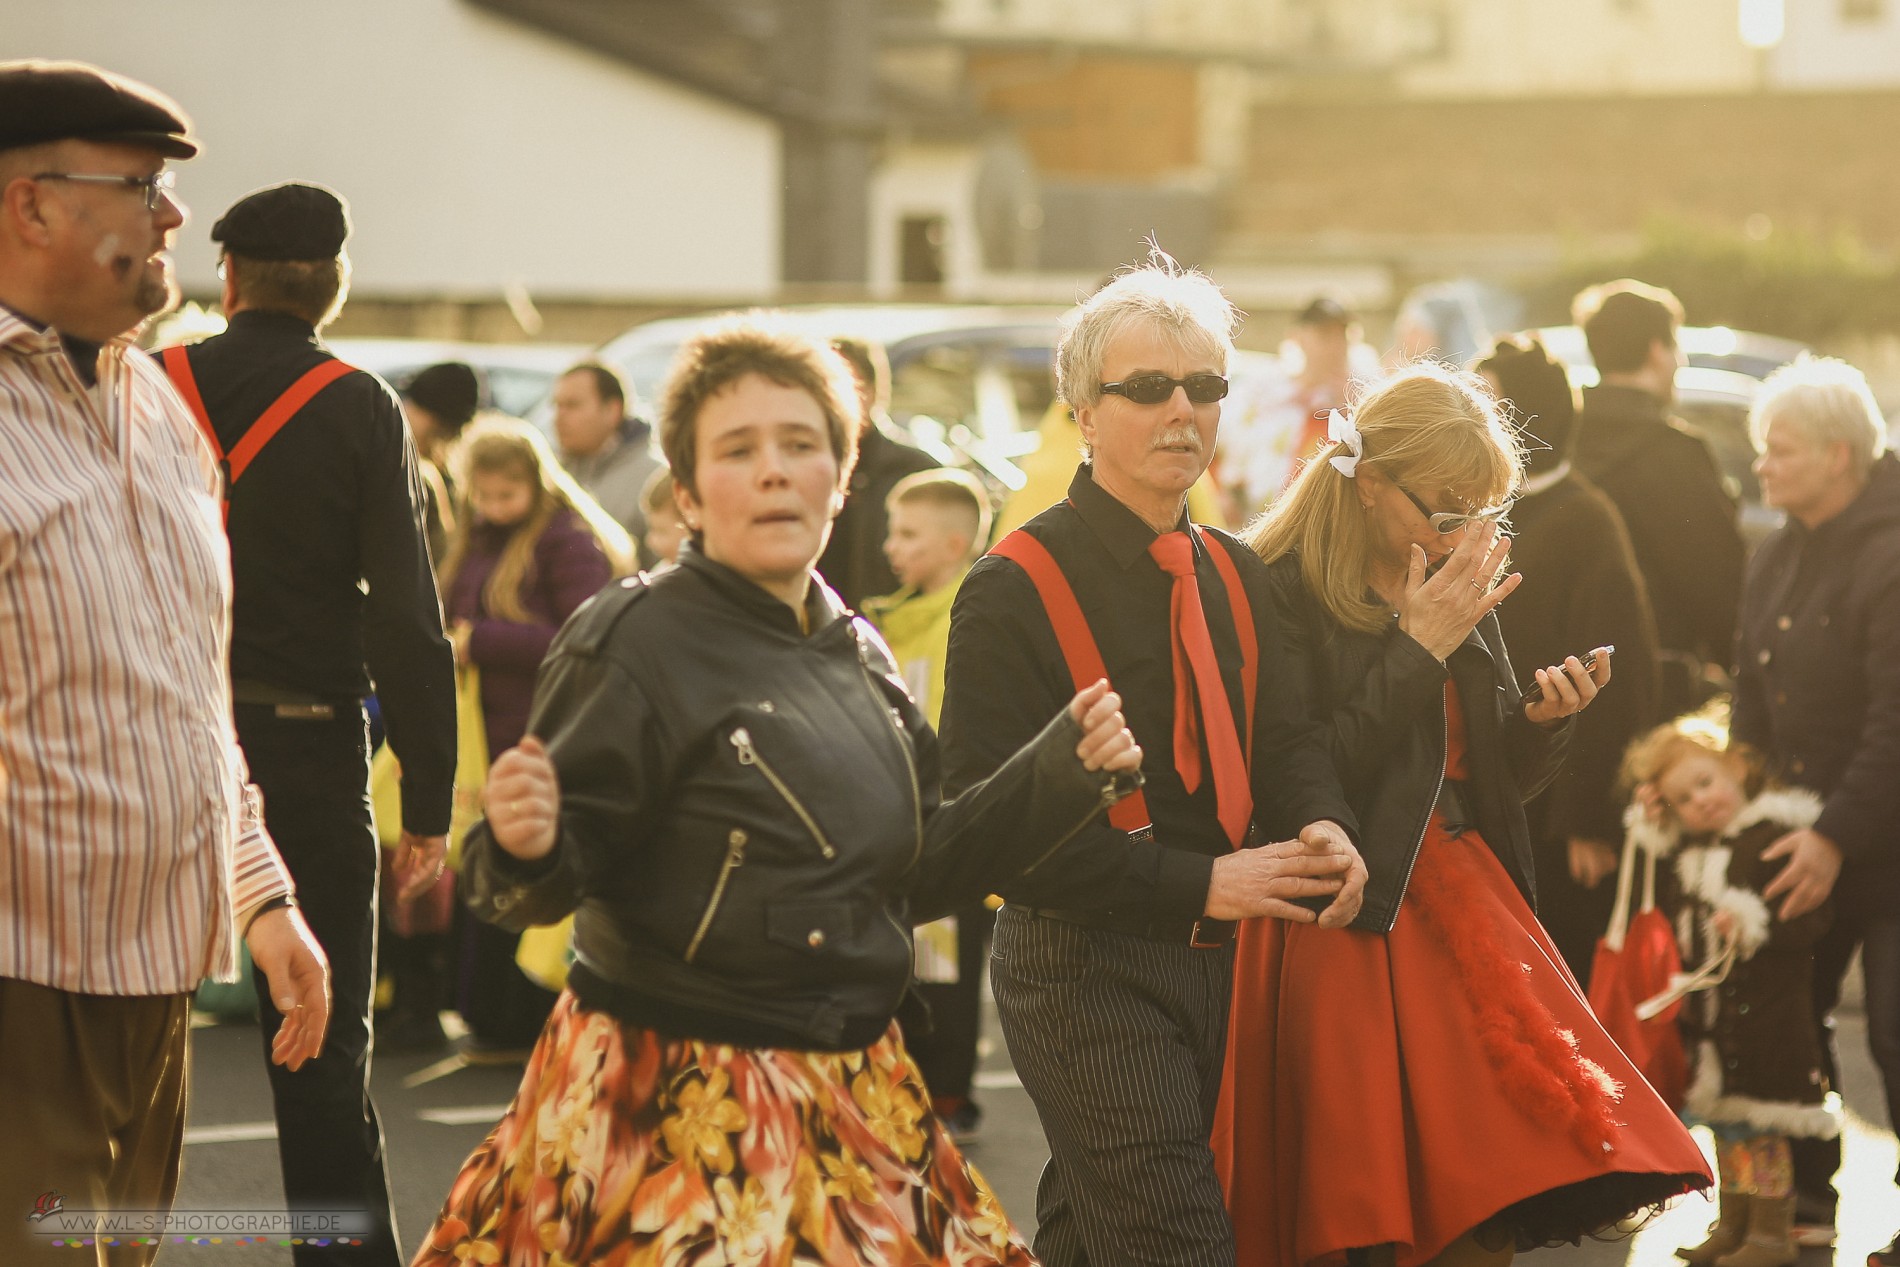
[416,321,1140,1265]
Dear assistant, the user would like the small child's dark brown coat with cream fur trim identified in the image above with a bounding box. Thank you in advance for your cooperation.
[1632,788,1841,1136]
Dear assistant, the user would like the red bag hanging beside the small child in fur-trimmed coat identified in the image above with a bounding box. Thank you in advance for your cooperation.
[1590,836,1689,1109]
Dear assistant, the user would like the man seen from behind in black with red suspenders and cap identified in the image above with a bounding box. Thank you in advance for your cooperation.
[160,184,456,1267]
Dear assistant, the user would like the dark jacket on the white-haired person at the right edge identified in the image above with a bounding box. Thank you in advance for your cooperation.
[1733,454,1900,910]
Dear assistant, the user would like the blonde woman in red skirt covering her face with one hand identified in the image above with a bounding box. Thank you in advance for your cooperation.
[1214,367,1710,1265]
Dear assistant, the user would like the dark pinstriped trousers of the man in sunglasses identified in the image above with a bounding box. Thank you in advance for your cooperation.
[990,906,1233,1267]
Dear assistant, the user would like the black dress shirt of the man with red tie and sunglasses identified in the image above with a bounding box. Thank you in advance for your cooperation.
[942,463,1355,919]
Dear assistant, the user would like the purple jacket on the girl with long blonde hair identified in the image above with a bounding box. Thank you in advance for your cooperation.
[443,511,614,760]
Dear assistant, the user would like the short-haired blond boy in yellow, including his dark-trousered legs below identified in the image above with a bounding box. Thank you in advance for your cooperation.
[865,469,994,1142]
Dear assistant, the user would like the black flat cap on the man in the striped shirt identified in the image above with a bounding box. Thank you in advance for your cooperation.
[0,59,198,158]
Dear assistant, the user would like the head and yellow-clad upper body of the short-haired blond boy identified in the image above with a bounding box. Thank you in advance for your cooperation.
[865,467,990,726]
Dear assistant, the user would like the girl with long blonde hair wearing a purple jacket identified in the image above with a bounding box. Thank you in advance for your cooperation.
[441,418,633,1050]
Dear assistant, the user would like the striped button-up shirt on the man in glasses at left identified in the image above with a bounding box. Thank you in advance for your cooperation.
[0,308,293,995]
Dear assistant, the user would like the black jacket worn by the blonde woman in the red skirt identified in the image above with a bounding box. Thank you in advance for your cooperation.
[1267,555,1571,933]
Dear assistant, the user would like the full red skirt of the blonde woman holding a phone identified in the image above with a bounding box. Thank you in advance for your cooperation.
[1214,817,1712,1267]
